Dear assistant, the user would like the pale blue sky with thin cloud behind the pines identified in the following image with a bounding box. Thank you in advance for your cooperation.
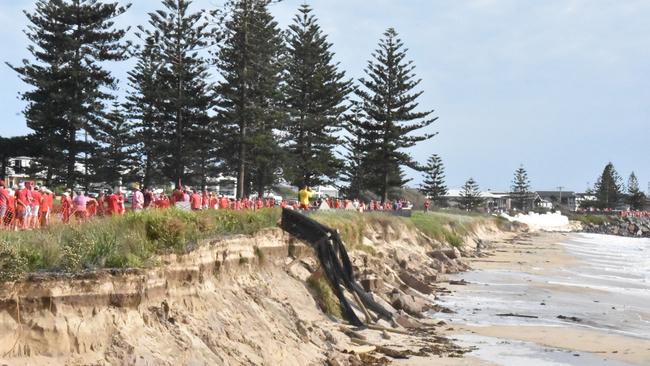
[0,0,650,191]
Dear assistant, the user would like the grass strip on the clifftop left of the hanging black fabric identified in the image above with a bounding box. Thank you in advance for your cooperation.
[0,209,280,281]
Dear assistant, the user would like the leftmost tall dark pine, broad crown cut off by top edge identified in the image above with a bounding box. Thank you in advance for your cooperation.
[9,0,129,187]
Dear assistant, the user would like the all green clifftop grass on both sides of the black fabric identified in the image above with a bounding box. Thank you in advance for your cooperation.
[0,209,496,281]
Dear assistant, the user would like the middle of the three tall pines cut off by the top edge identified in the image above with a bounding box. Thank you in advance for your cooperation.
[143,0,217,184]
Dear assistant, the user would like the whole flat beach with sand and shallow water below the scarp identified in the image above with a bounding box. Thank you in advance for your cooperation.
[418,233,650,365]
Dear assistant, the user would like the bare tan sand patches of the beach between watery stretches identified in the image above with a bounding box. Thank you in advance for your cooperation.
[422,233,650,365]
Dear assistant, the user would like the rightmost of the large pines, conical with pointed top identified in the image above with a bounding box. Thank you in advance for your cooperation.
[356,28,437,201]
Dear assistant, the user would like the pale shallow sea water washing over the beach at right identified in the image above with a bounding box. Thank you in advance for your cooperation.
[432,234,650,365]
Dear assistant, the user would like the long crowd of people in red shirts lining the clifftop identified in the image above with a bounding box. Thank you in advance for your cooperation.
[0,180,416,230]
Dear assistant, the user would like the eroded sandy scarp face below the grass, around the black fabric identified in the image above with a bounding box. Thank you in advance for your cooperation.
[0,213,503,366]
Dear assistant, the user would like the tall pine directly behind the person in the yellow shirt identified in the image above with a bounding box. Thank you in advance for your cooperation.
[283,5,351,186]
